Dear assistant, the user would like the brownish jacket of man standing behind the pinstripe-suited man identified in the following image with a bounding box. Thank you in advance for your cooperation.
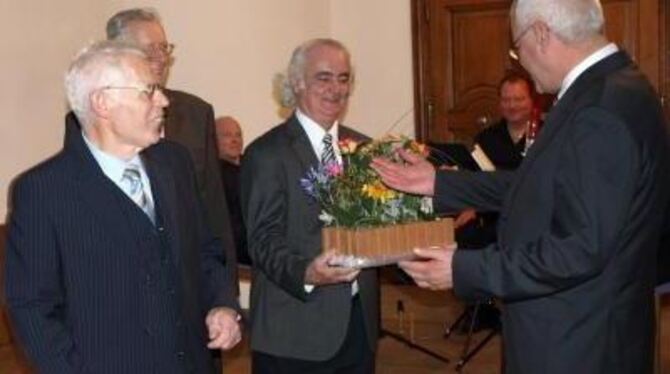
[165,90,237,294]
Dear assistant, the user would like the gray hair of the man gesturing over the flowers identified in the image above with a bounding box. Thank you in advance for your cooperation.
[512,0,605,43]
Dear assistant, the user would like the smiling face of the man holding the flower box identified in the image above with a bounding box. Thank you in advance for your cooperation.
[294,45,352,129]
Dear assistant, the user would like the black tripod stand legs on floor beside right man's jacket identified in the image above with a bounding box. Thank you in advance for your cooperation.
[444,300,502,372]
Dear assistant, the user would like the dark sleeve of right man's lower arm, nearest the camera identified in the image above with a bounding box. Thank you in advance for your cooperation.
[453,108,641,301]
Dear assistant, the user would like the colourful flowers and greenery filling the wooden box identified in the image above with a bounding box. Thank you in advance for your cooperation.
[300,137,433,228]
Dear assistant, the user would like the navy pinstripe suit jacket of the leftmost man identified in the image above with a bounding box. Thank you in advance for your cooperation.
[6,115,236,374]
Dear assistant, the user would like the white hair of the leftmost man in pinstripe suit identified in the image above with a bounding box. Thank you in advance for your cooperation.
[65,41,147,125]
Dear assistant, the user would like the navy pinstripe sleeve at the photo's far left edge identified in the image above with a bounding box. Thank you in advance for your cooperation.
[5,178,82,374]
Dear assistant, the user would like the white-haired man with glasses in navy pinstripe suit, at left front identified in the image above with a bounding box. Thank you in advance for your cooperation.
[6,42,240,374]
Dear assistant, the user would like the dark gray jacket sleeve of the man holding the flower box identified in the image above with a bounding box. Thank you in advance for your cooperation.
[240,147,312,300]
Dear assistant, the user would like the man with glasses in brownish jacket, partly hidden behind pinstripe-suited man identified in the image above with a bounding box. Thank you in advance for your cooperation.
[106,8,238,294]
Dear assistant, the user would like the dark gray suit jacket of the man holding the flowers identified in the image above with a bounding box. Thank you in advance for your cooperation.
[241,116,379,361]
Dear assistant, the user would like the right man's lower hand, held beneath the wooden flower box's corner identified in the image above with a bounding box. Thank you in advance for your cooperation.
[398,244,456,290]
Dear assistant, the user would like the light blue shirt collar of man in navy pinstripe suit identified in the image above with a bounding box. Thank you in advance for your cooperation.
[81,132,155,207]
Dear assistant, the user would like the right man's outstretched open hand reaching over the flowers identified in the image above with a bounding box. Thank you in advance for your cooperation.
[371,149,435,196]
